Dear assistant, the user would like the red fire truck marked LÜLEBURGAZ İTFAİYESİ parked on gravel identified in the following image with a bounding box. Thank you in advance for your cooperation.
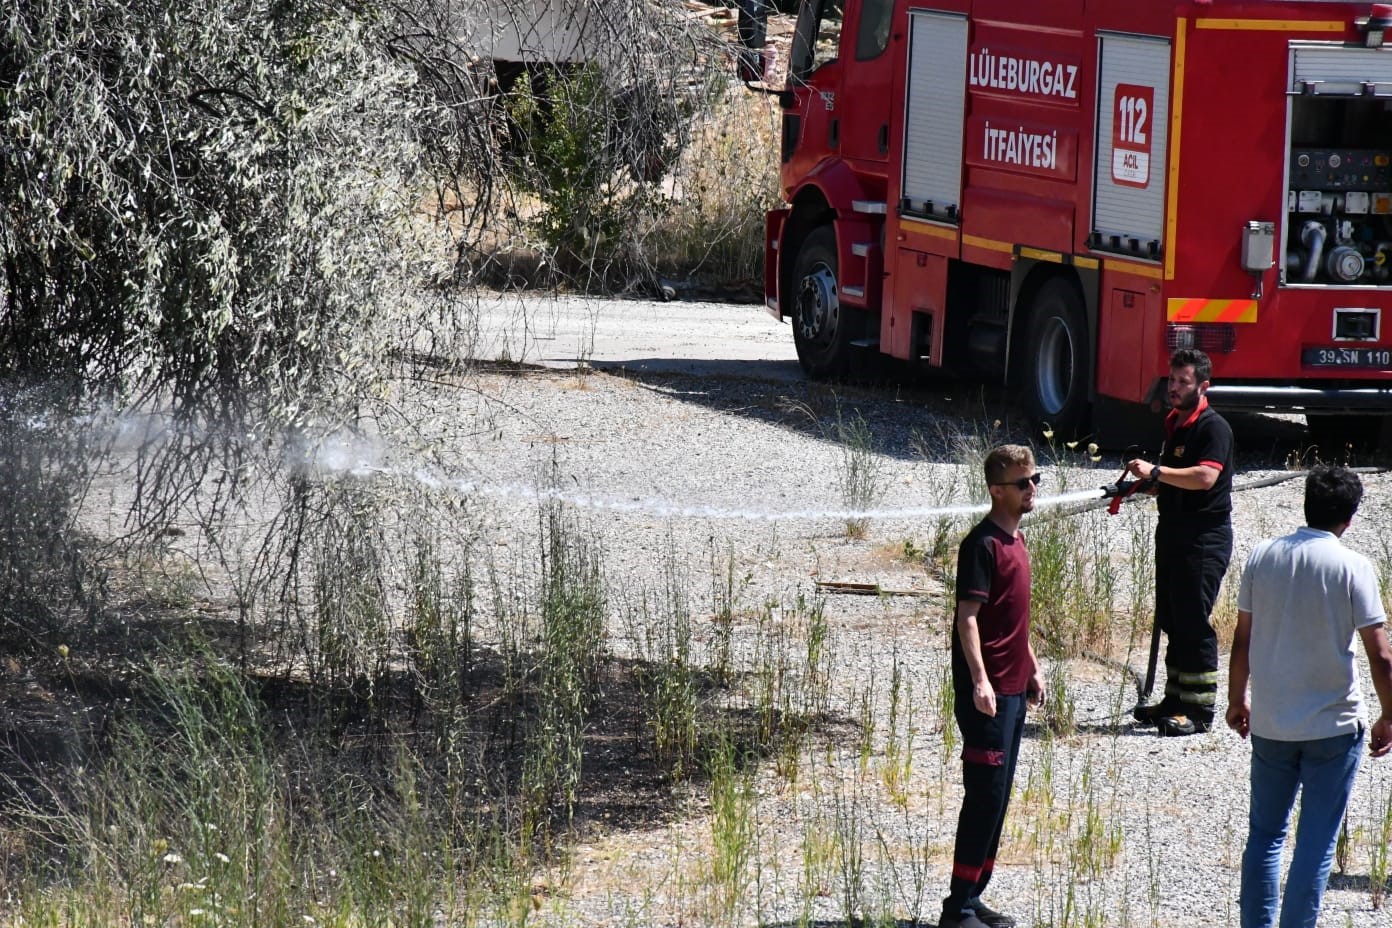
[741,0,1392,441]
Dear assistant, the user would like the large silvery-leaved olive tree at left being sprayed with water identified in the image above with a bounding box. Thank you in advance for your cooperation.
[0,0,466,623]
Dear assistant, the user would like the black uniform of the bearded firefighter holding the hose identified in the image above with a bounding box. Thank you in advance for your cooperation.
[1154,397,1232,733]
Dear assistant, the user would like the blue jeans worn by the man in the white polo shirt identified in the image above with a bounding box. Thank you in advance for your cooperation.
[1237,726,1364,928]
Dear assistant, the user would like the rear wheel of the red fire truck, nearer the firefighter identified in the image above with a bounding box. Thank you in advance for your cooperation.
[1022,277,1093,438]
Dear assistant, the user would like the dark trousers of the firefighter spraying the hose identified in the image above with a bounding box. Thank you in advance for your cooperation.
[1155,513,1232,722]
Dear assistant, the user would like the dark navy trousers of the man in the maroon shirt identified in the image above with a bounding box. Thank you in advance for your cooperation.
[942,687,1025,915]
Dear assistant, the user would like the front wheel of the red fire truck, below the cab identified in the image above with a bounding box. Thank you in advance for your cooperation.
[792,225,860,380]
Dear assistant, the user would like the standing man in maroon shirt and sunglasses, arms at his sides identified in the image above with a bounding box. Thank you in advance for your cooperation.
[938,445,1044,928]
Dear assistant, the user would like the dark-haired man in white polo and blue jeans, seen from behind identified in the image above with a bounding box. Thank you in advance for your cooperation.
[1228,465,1392,928]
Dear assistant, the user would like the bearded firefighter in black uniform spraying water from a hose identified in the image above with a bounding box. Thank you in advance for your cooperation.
[1126,348,1232,736]
